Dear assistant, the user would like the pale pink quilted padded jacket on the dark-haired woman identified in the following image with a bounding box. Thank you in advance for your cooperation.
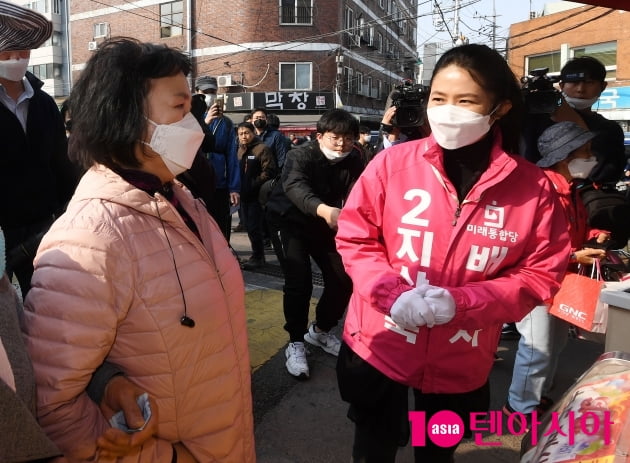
[24,166,255,463]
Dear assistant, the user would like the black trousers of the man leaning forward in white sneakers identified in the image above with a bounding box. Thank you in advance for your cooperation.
[267,213,352,342]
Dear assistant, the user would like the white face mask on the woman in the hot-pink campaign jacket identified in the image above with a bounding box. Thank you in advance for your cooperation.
[427,104,498,150]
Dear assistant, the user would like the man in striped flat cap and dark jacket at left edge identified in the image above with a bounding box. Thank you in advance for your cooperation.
[0,0,77,295]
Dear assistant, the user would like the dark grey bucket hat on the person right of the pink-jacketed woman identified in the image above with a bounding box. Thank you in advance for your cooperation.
[536,121,595,167]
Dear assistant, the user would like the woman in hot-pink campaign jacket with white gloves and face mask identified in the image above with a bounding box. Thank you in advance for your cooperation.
[336,45,570,463]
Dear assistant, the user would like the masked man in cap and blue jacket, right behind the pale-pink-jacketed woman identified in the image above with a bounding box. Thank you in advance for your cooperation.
[195,76,241,242]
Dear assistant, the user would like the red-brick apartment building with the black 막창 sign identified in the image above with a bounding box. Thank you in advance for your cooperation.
[66,0,418,128]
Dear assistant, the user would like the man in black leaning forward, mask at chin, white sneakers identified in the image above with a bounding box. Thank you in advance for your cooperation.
[267,109,363,378]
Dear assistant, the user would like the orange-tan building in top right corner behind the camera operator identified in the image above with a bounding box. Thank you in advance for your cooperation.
[507,2,630,132]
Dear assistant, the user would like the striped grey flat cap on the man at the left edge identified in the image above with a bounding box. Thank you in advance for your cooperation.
[0,0,52,51]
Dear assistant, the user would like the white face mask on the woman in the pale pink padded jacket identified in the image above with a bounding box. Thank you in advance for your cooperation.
[142,113,204,175]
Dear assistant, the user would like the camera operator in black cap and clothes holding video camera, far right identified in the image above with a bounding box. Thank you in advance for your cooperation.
[522,56,630,250]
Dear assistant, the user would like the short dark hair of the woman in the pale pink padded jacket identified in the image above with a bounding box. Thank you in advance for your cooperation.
[68,37,190,168]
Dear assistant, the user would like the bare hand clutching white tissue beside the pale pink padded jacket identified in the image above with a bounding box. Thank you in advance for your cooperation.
[96,375,158,458]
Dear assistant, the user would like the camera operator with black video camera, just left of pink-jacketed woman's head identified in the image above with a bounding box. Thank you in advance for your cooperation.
[376,81,431,152]
